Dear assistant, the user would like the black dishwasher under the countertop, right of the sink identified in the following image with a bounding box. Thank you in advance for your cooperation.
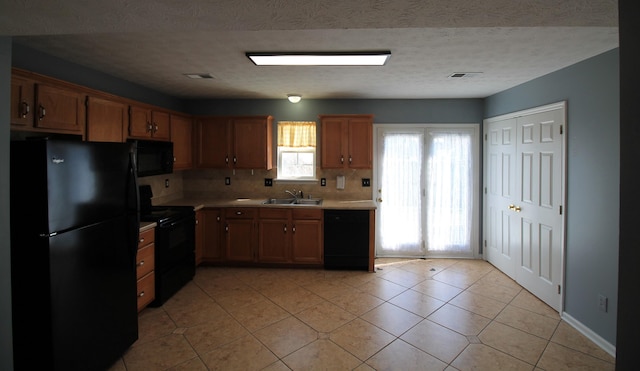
[324,209,369,270]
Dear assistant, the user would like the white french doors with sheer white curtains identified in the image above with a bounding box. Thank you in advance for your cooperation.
[374,124,480,258]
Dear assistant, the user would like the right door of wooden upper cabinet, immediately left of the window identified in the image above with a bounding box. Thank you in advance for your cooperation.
[232,118,273,170]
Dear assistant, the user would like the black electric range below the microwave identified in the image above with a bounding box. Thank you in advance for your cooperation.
[139,186,196,307]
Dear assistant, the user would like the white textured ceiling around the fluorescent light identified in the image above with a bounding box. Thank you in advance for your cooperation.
[0,0,618,99]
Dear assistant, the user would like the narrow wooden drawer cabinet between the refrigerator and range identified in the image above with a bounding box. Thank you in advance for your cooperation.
[136,228,156,312]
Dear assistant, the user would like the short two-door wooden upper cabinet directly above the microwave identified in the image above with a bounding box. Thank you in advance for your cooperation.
[129,106,171,140]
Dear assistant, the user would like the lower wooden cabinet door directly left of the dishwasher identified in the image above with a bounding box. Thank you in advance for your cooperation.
[291,219,323,264]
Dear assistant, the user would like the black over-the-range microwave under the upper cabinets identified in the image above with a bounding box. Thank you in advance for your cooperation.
[128,140,173,177]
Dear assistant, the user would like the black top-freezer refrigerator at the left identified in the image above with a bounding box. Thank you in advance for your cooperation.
[10,139,139,370]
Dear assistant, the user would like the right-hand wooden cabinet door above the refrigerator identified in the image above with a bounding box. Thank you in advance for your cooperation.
[35,84,85,133]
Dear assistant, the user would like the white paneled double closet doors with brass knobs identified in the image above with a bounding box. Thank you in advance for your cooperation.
[484,103,566,311]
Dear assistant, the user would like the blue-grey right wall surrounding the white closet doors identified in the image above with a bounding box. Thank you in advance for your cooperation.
[484,49,620,344]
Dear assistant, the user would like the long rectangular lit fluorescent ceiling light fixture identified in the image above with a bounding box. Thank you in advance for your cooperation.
[246,50,391,66]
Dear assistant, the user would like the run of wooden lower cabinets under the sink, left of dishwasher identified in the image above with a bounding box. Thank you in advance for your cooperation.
[196,207,324,267]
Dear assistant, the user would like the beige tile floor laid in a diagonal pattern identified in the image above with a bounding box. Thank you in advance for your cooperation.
[111,259,615,371]
